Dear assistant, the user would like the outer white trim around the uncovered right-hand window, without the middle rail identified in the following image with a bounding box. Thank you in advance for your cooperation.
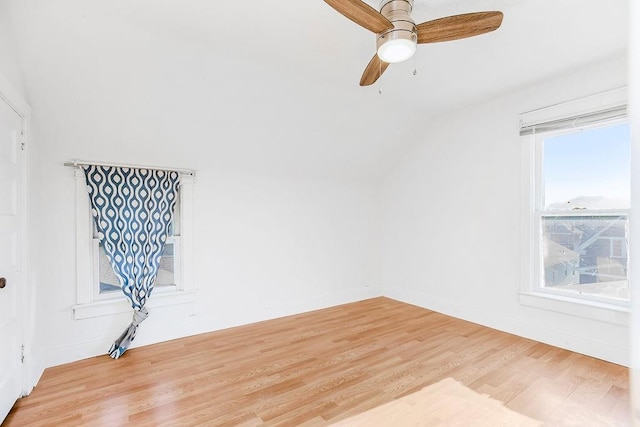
[519,87,630,326]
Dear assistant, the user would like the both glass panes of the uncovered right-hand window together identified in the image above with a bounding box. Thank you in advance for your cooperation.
[538,123,630,300]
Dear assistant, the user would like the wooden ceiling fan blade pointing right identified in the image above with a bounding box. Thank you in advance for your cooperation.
[416,12,503,43]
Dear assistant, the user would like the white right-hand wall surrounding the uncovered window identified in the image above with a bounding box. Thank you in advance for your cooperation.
[381,55,629,364]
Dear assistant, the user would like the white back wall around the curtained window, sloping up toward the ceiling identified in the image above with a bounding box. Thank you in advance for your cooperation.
[11,1,392,366]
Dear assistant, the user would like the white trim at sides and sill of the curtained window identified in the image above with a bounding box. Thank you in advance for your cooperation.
[72,168,196,320]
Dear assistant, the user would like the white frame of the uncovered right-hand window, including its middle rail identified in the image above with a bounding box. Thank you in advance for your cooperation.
[519,87,630,325]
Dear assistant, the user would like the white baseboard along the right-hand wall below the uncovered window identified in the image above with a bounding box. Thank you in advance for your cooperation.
[383,287,630,366]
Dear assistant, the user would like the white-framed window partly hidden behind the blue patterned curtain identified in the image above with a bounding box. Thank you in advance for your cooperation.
[73,168,195,319]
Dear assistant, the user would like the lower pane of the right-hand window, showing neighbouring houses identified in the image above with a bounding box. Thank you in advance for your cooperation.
[542,216,629,299]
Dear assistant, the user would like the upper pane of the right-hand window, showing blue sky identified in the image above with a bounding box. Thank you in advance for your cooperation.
[542,123,631,210]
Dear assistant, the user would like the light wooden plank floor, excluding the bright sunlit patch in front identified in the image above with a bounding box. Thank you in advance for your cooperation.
[3,298,630,427]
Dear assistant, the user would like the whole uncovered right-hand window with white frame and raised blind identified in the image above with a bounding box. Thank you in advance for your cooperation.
[521,88,631,314]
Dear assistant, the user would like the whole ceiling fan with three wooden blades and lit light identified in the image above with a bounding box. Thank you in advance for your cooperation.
[324,0,503,86]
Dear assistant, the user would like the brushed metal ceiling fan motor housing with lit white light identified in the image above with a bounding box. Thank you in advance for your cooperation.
[376,0,418,63]
